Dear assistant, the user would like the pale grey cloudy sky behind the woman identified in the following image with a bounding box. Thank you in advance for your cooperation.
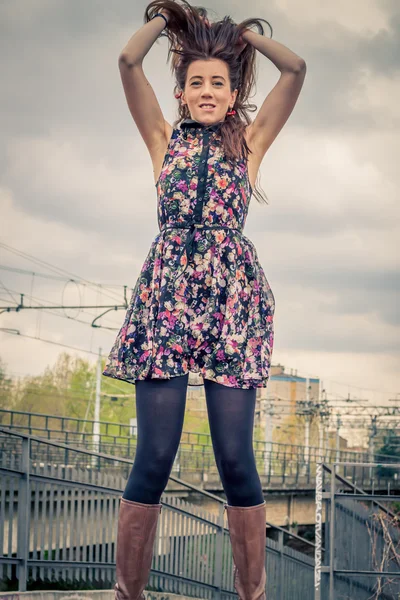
[0,0,400,403]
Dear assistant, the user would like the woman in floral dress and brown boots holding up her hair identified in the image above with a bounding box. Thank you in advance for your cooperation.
[103,0,306,600]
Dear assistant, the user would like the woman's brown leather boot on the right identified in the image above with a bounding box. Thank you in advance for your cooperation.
[224,501,267,600]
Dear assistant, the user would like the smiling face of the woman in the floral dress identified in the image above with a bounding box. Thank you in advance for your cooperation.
[181,58,238,125]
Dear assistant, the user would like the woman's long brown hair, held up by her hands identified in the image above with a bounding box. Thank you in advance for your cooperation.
[144,0,272,204]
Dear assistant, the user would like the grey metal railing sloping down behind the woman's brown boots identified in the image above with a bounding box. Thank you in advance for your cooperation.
[0,428,314,600]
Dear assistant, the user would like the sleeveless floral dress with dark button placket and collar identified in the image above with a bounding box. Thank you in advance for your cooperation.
[103,119,275,389]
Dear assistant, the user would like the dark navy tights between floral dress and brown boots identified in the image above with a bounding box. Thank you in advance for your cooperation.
[123,374,264,506]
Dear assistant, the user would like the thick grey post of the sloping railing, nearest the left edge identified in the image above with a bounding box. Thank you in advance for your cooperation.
[17,437,31,592]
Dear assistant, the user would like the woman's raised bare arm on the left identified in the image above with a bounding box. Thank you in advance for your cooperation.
[118,11,172,158]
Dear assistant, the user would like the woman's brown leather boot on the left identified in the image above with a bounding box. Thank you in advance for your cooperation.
[114,497,162,600]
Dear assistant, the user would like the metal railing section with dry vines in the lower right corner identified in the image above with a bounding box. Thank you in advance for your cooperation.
[314,463,400,600]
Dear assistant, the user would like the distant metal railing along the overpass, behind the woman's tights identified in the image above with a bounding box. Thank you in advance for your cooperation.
[0,409,396,489]
